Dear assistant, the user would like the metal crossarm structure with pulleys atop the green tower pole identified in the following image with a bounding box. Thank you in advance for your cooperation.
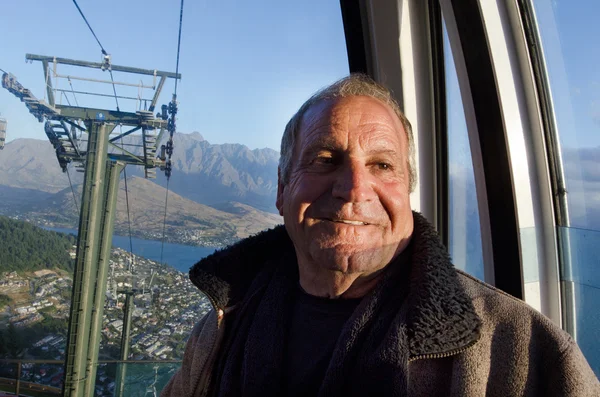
[2,54,181,178]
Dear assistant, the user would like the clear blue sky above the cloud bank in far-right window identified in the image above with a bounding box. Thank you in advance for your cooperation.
[533,0,600,147]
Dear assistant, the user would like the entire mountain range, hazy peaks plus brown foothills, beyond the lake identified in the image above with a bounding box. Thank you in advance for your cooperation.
[0,132,281,246]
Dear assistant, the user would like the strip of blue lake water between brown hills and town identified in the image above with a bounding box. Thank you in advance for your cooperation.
[44,227,216,274]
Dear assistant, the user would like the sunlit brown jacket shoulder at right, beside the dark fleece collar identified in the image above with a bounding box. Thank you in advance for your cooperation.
[457,270,600,396]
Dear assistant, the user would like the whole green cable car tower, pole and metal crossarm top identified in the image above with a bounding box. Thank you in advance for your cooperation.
[2,51,181,396]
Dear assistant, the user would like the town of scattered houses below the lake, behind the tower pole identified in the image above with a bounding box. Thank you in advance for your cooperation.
[0,244,211,395]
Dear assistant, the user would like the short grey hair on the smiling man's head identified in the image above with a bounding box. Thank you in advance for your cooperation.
[279,74,417,193]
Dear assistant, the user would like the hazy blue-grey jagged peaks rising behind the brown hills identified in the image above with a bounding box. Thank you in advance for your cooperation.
[0,132,279,213]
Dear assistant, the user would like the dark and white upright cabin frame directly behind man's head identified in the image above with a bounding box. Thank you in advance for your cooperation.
[358,0,437,224]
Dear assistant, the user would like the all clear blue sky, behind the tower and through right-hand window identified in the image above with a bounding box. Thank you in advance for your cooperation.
[0,0,600,153]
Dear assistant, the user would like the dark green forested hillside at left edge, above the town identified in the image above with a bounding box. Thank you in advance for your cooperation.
[0,216,77,272]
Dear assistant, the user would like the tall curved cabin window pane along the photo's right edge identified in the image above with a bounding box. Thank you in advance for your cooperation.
[532,0,600,375]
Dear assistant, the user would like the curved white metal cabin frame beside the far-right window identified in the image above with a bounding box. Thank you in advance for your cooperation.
[474,0,561,324]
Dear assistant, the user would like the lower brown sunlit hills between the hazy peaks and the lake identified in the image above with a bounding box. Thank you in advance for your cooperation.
[20,176,281,246]
